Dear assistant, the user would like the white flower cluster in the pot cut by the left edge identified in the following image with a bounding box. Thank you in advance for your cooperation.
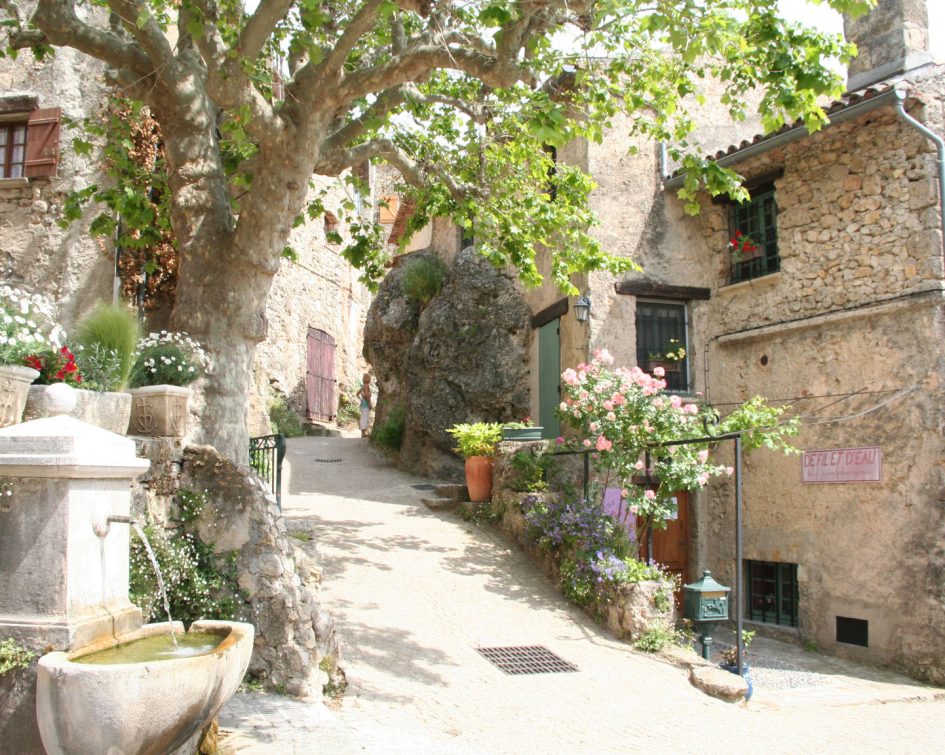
[0,286,65,364]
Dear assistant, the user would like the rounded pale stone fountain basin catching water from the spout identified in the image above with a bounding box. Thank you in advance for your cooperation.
[36,621,253,755]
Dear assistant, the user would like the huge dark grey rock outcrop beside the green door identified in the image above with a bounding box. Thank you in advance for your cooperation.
[364,247,532,478]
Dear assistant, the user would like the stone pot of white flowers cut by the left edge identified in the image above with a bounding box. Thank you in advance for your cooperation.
[0,286,61,427]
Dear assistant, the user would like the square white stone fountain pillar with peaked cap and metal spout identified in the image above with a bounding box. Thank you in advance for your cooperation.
[0,415,148,753]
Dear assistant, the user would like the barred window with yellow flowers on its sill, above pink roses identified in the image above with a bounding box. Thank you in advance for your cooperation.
[636,300,689,393]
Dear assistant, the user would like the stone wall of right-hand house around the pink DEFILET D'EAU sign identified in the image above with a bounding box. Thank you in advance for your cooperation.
[564,62,945,682]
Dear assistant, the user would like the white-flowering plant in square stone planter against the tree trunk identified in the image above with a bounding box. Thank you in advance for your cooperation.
[128,330,209,437]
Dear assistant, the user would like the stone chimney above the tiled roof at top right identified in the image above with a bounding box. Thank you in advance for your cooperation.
[843,0,932,91]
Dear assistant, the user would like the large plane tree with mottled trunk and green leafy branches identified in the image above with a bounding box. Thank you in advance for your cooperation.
[0,0,875,463]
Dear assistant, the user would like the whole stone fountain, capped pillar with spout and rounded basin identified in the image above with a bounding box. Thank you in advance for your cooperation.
[0,389,253,755]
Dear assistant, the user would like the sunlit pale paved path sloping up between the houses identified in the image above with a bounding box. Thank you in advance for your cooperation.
[221,438,945,755]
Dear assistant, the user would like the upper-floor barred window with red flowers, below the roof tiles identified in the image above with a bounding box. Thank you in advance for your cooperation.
[729,185,781,283]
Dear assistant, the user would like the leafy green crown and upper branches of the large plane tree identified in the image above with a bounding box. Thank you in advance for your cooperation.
[4,0,874,289]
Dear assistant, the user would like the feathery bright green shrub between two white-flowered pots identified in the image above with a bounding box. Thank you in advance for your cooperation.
[72,302,141,391]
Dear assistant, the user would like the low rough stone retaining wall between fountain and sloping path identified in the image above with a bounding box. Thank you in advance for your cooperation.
[132,438,338,697]
